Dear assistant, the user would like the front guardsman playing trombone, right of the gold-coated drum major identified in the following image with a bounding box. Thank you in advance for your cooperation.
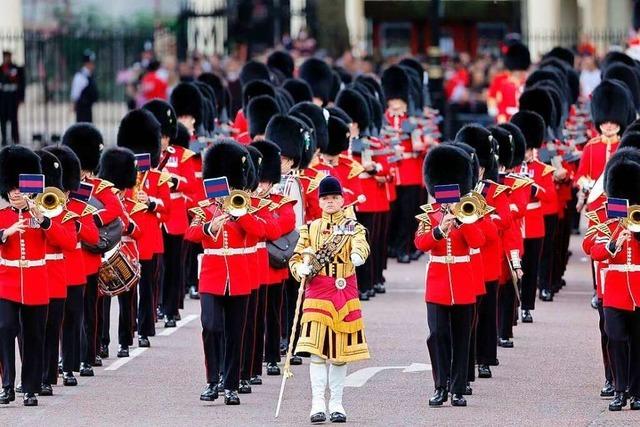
[415,145,485,406]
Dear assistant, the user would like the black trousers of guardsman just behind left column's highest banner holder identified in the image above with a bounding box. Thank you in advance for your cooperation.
[162,231,184,317]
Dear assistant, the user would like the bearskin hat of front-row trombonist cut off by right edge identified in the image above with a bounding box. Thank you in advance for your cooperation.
[604,148,640,205]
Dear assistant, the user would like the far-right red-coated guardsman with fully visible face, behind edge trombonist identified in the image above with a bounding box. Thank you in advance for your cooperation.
[574,80,634,210]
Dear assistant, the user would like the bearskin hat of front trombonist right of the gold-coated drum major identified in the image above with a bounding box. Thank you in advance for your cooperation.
[422,144,474,196]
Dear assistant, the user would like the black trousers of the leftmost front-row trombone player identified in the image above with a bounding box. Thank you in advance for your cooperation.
[0,299,48,393]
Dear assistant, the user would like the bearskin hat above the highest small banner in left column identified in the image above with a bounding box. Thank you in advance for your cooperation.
[117,109,160,167]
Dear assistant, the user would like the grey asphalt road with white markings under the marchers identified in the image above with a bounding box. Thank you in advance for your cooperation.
[0,239,640,426]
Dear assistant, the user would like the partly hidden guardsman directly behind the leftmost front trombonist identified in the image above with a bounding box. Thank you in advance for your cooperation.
[36,150,78,396]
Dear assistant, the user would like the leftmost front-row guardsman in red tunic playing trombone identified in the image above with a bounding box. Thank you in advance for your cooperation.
[0,145,68,406]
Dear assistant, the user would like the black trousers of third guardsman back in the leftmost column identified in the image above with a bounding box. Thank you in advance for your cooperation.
[61,285,84,372]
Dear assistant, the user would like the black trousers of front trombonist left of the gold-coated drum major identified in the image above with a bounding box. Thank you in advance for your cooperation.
[200,294,249,390]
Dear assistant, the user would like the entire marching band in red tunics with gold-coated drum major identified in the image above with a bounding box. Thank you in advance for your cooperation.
[0,42,640,423]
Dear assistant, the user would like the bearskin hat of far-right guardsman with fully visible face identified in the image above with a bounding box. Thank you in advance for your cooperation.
[591,80,634,133]
